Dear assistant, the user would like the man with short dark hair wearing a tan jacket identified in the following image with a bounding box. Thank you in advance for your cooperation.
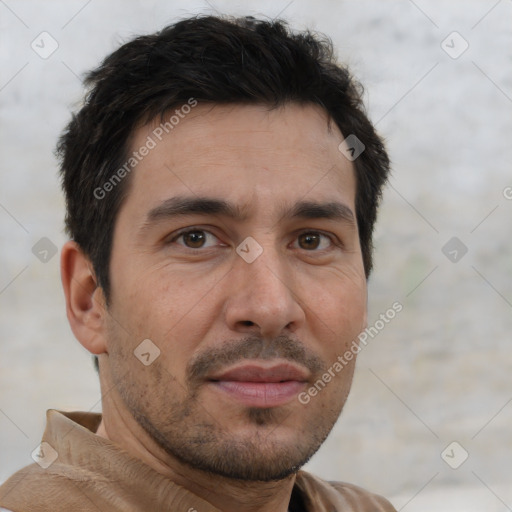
[0,16,394,512]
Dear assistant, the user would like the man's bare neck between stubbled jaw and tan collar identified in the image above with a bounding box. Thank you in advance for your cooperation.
[96,364,295,512]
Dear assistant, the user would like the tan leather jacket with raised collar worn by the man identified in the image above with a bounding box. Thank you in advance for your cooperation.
[0,410,396,512]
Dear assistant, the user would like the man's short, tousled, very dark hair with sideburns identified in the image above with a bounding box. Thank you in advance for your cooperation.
[57,16,389,301]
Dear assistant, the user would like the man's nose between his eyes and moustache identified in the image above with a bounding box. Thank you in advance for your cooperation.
[225,250,305,338]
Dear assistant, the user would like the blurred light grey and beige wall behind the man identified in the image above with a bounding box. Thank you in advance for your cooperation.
[0,0,512,512]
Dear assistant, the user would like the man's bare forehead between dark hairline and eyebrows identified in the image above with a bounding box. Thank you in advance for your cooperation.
[122,103,355,220]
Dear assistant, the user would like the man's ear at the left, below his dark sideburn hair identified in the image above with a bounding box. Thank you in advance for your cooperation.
[60,241,107,354]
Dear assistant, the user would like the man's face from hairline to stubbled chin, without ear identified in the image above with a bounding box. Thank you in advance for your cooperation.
[105,104,366,480]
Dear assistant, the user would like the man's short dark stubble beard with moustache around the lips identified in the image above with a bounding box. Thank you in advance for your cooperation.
[113,338,352,482]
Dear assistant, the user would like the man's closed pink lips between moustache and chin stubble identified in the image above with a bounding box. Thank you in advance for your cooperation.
[208,362,309,408]
